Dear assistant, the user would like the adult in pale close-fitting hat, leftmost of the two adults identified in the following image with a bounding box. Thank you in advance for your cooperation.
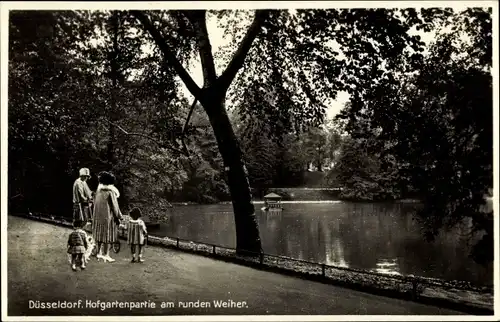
[73,168,92,223]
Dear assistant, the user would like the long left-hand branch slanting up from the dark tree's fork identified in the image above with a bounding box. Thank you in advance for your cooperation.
[130,10,200,97]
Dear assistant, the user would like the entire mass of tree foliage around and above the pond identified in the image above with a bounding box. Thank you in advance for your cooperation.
[9,8,493,260]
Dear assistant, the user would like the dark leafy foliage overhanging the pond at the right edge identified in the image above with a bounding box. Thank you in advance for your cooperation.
[334,9,493,262]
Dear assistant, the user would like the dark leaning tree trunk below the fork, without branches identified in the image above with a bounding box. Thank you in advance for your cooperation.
[200,89,262,254]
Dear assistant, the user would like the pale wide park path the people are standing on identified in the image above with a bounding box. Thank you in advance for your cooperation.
[7,216,460,316]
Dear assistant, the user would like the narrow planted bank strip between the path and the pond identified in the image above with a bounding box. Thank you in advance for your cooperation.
[10,214,493,315]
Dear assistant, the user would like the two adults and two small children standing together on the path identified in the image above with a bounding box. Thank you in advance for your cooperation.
[67,168,147,271]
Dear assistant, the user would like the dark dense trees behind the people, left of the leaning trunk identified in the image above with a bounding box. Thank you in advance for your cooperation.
[9,11,228,216]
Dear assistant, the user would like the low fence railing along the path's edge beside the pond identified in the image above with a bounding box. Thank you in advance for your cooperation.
[11,214,493,309]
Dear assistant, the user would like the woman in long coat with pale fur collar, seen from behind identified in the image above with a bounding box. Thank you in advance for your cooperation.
[92,172,123,262]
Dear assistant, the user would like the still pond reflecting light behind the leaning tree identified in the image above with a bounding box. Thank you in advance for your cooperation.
[150,202,493,285]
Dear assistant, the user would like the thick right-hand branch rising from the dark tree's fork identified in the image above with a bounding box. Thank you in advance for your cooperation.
[219,10,269,90]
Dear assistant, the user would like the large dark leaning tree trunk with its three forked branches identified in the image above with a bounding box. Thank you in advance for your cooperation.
[132,10,269,254]
